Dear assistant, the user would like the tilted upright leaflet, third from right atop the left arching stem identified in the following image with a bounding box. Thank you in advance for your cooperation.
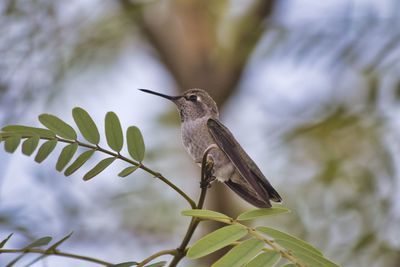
[72,107,100,145]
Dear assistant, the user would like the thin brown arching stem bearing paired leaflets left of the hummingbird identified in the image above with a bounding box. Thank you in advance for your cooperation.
[3,133,196,209]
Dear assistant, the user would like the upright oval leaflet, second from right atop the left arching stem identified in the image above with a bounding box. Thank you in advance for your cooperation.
[105,112,124,152]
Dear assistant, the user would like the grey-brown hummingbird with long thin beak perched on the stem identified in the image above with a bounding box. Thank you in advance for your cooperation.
[139,89,282,208]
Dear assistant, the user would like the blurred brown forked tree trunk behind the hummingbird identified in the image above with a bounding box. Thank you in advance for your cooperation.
[120,0,275,260]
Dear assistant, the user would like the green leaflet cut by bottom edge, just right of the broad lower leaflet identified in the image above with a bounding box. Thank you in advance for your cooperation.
[212,239,264,267]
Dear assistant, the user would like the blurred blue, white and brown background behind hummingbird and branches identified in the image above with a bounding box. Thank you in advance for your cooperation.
[0,0,400,267]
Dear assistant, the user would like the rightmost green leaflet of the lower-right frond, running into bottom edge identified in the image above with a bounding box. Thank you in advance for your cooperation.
[275,239,339,267]
